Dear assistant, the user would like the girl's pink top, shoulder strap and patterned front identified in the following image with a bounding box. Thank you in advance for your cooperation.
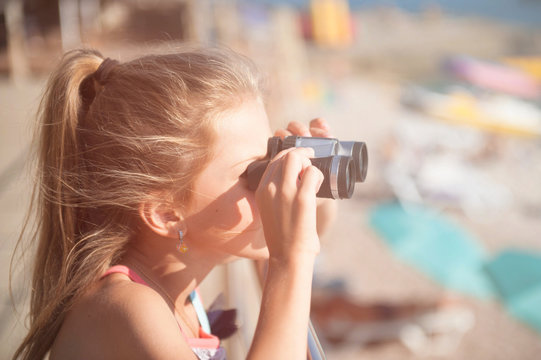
[101,265,225,360]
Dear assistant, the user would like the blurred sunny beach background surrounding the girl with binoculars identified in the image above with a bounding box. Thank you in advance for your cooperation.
[0,0,541,359]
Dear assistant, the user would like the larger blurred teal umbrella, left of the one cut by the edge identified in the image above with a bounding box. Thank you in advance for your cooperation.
[370,202,494,298]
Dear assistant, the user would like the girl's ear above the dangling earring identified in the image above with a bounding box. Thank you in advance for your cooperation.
[139,202,183,238]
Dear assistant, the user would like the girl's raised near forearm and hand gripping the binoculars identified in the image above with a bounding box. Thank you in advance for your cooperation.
[248,148,323,359]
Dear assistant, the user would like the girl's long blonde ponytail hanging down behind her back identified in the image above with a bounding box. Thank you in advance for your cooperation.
[14,50,102,359]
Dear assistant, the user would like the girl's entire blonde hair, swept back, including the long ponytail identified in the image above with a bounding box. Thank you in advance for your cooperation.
[14,49,261,359]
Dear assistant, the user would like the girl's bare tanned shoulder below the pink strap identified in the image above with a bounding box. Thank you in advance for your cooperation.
[50,274,193,359]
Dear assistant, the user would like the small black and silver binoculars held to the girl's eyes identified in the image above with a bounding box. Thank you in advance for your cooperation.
[244,136,368,199]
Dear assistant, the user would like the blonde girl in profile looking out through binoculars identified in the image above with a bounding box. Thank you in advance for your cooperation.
[14,50,334,359]
